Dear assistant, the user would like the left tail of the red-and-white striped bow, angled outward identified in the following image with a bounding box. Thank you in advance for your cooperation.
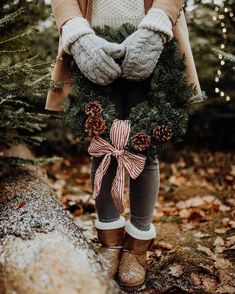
[92,154,111,199]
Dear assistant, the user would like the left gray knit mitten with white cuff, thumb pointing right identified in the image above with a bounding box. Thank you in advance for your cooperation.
[62,17,125,85]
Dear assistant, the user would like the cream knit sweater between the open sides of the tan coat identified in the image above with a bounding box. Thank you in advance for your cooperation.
[91,0,145,29]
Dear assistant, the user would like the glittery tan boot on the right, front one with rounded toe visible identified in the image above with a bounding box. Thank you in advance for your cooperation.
[118,221,156,290]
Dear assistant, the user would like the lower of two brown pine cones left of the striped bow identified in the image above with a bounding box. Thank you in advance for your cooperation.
[85,116,106,137]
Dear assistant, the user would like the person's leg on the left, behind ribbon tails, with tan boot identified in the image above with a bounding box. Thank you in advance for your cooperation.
[91,80,129,278]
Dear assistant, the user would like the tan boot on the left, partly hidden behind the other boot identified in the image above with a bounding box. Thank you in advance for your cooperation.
[95,217,125,278]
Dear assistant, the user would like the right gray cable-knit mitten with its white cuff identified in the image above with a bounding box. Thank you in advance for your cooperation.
[121,8,173,81]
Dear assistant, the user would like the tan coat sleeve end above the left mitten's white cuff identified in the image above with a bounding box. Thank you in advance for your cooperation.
[51,0,82,32]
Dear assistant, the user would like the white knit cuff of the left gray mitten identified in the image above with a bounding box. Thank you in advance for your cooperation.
[61,17,95,54]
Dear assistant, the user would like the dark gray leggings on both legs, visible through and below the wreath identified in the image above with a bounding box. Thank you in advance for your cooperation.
[91,79,160,231]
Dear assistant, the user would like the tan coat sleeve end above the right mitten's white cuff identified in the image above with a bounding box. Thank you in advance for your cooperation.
[152,0,185,26]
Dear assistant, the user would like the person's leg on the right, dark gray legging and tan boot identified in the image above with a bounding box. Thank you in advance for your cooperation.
[118,80,159,289]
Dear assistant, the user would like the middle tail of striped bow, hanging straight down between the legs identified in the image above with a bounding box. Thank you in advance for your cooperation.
[111,161,125,213]
